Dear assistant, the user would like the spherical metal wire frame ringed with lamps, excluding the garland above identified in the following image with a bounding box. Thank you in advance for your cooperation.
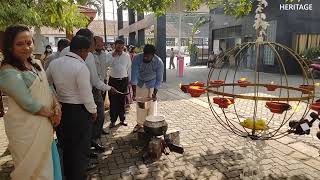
[206,41,315,140]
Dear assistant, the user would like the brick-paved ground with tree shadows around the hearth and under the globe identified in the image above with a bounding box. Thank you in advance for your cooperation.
[0,69,320,180]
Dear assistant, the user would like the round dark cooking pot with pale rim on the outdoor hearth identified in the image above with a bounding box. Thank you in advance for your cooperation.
[143,116,168,136]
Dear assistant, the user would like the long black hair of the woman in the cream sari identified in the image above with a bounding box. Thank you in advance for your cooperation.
[2,25,41,71]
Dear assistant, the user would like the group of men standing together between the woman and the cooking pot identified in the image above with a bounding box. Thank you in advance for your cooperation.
[45,29,164,180]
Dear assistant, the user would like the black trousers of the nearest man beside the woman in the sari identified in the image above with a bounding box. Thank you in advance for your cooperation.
[61,103,92,180]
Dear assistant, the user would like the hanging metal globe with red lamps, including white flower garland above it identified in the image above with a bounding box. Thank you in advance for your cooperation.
[180,0,320,140]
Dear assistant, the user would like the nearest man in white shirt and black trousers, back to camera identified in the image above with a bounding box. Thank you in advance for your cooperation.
[46,36,97,180]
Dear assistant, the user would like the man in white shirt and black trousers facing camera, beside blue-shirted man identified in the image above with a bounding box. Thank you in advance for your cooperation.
[107,40,131,128]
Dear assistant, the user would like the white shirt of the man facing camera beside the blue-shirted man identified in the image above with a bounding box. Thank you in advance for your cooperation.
[107,52,131,81]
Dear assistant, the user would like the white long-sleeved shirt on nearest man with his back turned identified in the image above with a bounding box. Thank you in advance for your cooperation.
[46,52,97,113]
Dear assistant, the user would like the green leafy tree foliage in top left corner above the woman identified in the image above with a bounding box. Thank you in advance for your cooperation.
[0,0,88,31]
